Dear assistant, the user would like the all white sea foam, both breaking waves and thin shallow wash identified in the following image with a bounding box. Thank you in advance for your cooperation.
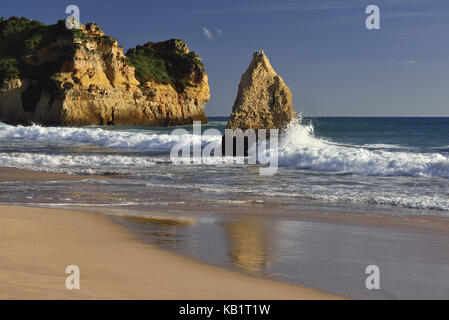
[0,123,449,211]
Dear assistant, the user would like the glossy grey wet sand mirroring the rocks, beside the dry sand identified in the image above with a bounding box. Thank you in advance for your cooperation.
[109,208,449,299]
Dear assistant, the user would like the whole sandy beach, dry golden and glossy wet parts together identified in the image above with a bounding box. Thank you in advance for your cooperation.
[0,168,449,299]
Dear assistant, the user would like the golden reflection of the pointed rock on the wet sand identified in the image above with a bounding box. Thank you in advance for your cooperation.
[221,217,273,272]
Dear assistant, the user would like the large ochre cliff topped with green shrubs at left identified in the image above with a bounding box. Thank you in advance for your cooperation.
[0,17,210,126]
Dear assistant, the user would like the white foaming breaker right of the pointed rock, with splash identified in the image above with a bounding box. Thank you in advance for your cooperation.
[279,124,449,178]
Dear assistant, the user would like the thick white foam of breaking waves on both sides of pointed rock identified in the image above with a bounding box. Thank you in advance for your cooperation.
[0,123,449,178]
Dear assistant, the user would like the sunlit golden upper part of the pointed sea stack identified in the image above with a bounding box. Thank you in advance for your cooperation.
[227,51,297,130]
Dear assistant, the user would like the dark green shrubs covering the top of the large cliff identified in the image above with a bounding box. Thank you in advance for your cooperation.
[0,17,204,95]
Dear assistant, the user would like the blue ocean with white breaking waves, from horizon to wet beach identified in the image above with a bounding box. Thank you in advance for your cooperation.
[0,117,449,216]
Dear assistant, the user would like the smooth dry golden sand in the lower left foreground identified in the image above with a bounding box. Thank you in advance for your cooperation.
[0,206,338,299]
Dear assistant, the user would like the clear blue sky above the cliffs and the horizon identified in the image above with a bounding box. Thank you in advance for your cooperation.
[0,0,449,116]
